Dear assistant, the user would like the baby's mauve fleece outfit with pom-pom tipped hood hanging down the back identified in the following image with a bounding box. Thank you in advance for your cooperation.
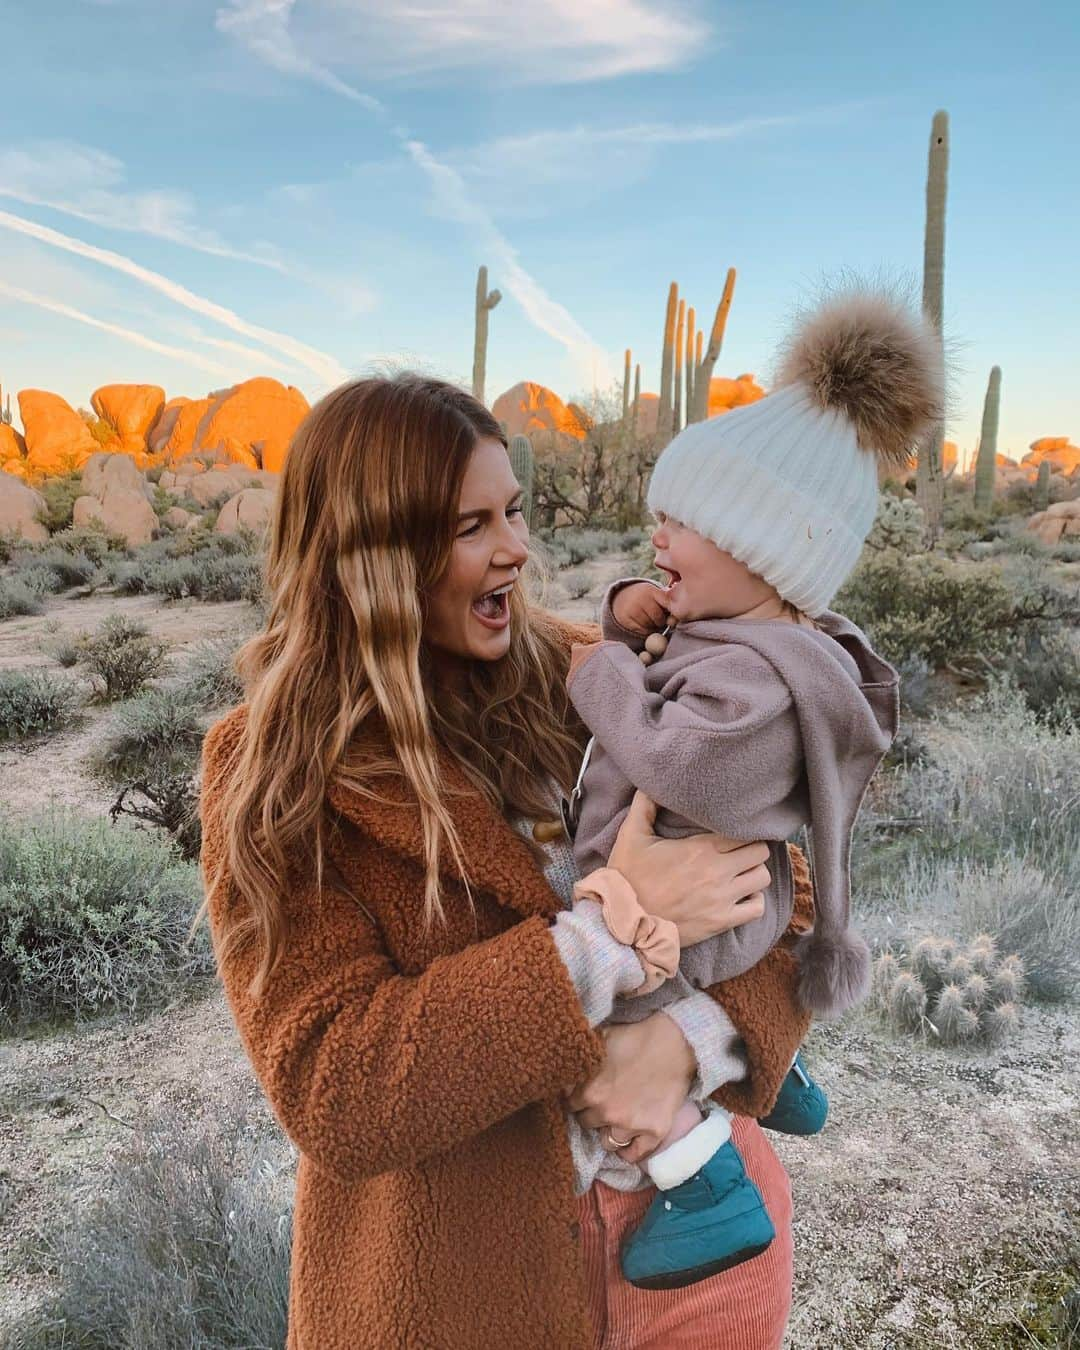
[568,579,899,1022]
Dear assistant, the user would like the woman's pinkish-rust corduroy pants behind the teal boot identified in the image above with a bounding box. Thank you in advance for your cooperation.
[579,1116,792,1350]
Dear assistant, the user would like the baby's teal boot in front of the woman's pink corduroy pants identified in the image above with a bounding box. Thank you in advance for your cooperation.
[621,1139,776,1289]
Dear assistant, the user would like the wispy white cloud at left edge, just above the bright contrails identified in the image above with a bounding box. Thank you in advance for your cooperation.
[0,140,285,271]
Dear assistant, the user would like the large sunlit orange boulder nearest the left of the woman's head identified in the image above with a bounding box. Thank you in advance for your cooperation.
[194,377,309,473]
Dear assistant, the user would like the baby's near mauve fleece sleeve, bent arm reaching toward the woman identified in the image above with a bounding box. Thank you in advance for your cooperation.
[570,641,803,840]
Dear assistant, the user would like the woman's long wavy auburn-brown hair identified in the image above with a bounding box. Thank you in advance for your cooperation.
[194,374,579,996]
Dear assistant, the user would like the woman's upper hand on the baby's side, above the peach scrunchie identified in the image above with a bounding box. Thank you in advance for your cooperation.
[608,792,772,946]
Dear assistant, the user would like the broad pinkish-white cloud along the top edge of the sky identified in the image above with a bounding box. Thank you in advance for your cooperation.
[217,0,714,85]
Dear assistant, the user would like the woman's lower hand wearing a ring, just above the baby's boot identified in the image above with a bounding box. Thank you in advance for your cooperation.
[568,1013,698,1162]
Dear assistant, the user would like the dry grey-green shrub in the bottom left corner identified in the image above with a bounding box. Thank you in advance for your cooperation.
[16,1094,294,1350]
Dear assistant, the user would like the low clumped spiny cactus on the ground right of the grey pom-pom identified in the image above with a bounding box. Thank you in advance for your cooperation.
[871,934,1023,1045]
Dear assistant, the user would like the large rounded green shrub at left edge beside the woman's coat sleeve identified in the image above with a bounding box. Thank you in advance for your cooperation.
[0,811,213,1026]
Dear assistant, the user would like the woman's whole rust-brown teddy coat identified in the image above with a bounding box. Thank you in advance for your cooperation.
[200,625,811,1350]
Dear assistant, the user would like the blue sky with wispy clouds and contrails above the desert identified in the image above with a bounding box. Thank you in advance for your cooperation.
[0,0,1080,458]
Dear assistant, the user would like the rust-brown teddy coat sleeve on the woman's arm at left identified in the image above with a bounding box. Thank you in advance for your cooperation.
[200,729,603,1183]
